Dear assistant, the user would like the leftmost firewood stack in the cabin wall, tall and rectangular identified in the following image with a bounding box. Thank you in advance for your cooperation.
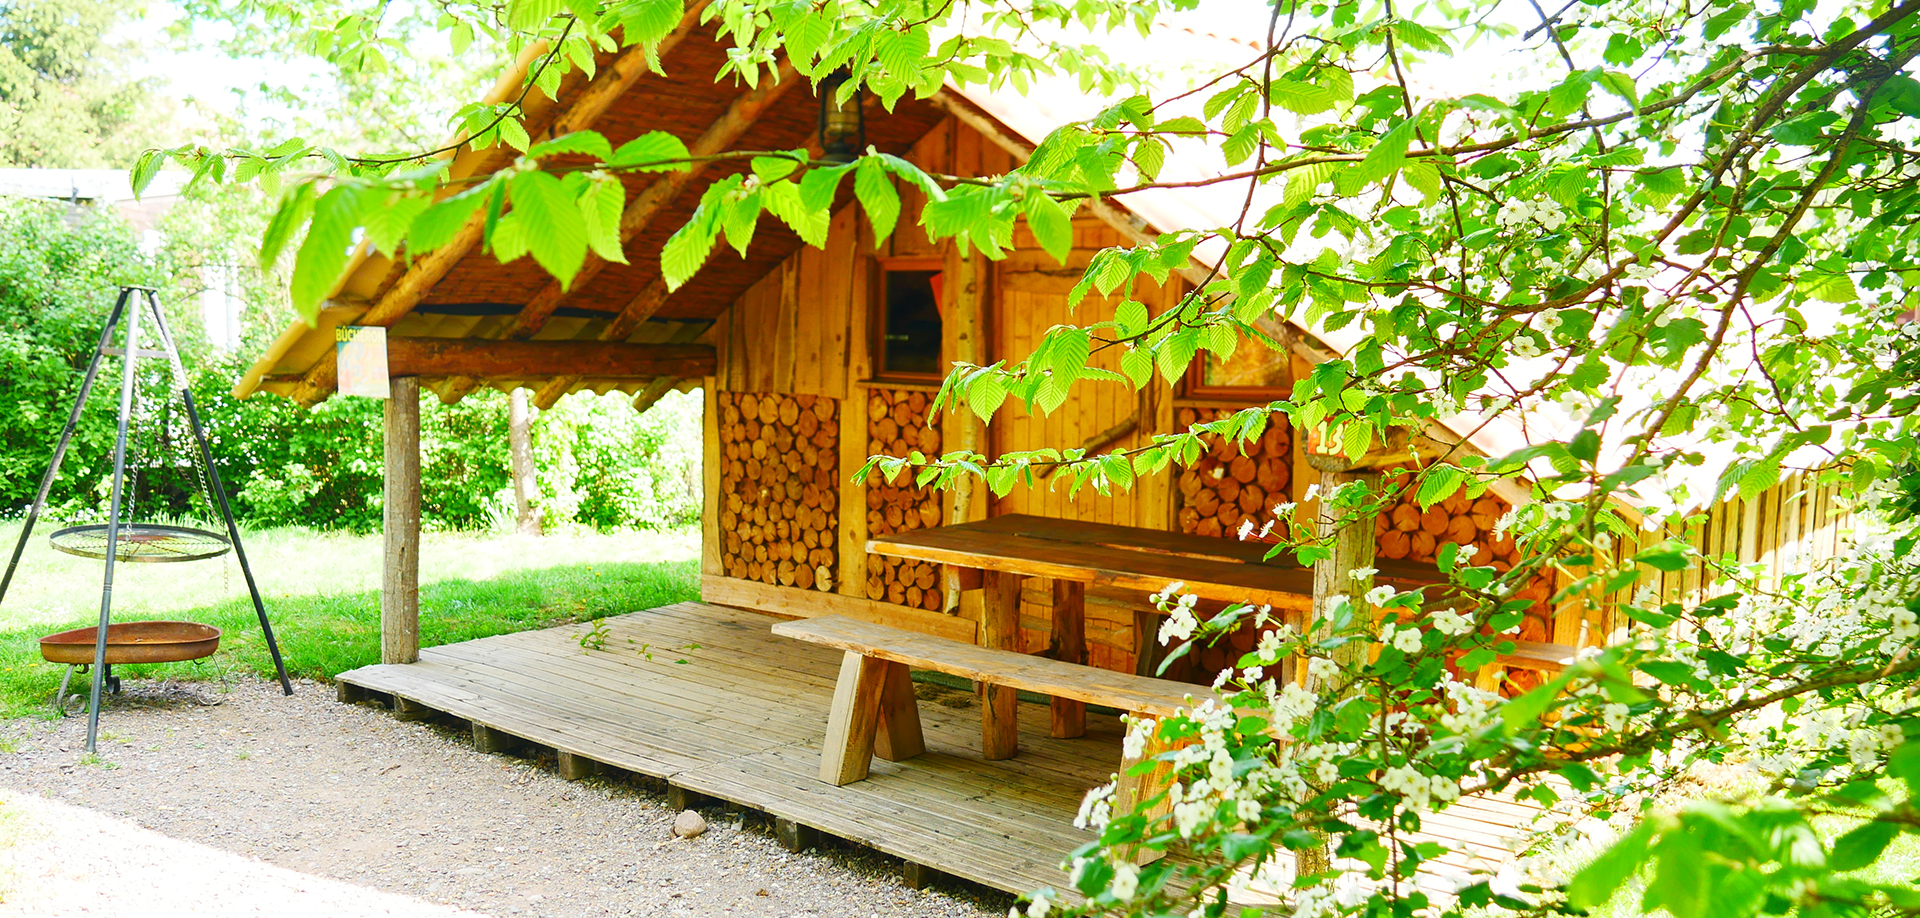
[718,392,839,590]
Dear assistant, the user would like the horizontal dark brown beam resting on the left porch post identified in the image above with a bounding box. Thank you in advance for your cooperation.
[386,338,714,380]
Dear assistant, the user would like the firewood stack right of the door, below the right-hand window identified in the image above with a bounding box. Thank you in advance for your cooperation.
[1175,407,1294,538]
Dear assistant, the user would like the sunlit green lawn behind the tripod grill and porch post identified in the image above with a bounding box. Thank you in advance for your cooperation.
[0,522,699,716]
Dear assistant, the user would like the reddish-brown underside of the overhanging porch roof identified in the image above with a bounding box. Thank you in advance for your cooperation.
[234,16,947,405]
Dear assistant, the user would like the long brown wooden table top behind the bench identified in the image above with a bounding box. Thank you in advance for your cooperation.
[866,513,1438,613]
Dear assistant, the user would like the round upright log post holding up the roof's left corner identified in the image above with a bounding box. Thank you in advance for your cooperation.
[380,376,420,663]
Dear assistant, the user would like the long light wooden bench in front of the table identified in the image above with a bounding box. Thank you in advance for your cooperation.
[774,615,1217,812]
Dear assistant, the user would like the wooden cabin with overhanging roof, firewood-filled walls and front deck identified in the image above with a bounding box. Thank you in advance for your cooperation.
[236,17,1845,889]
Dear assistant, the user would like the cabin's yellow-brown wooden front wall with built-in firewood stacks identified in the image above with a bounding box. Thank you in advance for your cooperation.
[703,112,1847,670]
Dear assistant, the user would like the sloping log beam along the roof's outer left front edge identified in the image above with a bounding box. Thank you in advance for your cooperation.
[280,0,710,407]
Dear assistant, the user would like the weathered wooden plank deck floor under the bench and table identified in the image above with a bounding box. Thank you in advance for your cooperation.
[340,603,1528,893]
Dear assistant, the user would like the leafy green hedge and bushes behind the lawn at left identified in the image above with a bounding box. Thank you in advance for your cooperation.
[0,196,701,532]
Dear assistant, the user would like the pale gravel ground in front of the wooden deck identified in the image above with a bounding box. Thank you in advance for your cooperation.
[0,682,1010,918]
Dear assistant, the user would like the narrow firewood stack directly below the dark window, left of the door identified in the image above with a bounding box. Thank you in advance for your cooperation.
[866,388,945,611]
